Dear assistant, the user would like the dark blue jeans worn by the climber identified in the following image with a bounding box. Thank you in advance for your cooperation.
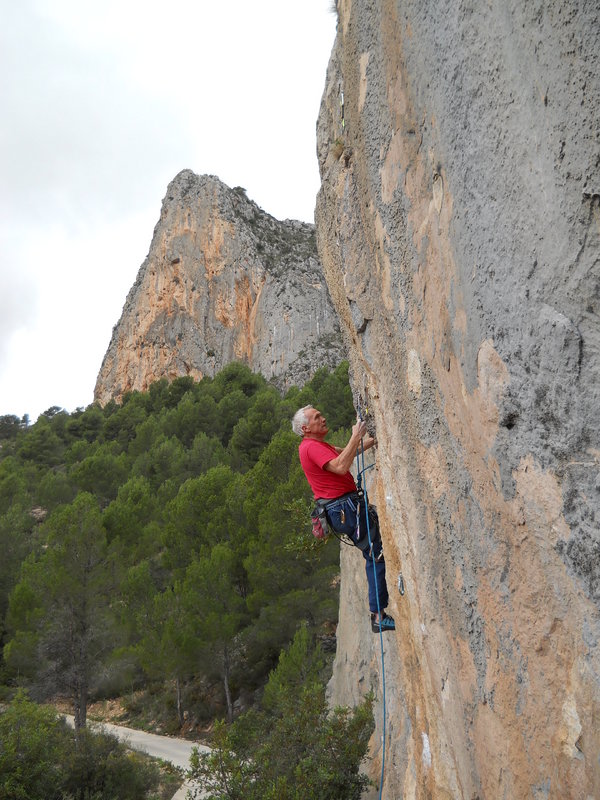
[327,495,389,614]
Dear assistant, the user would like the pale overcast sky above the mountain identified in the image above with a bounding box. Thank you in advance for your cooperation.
[0,0,336,421]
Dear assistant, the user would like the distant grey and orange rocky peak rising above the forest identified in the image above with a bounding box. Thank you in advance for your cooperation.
[94,170,343,404]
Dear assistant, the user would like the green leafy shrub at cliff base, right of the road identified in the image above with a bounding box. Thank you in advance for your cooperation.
[190,626,373,800]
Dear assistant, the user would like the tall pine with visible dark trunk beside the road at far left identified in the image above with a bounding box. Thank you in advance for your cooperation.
[5,494,117,729]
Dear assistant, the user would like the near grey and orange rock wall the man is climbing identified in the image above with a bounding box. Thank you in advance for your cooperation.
[316,0,600,800]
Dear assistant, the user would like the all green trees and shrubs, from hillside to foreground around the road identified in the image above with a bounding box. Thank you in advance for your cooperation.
[0,362,373,800]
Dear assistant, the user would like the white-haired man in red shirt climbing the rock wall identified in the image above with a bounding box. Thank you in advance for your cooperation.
[292,406,396,633]
